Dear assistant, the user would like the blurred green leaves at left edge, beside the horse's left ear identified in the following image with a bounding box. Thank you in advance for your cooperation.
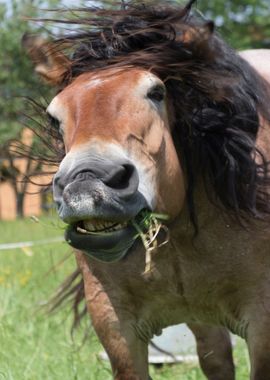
[0,0,49,145]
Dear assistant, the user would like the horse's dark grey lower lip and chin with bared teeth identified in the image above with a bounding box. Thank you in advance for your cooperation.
[65,212,146,262]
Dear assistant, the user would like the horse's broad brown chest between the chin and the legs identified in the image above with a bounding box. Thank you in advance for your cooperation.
[80,218,270,340]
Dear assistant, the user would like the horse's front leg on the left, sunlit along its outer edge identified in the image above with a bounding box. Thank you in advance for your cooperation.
[77,253,149,380]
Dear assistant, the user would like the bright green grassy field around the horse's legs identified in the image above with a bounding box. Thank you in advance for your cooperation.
[0,218,249,380]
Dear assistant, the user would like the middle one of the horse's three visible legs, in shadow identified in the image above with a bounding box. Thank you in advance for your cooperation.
[188,324,235,380]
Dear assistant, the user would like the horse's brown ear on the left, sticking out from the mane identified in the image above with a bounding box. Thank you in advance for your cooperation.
[22,33,70,85]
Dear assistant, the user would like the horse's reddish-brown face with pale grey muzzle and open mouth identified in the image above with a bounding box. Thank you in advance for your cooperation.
[47,67,185,260]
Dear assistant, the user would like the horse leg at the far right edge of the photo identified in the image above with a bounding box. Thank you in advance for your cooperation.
[247,320,270,380]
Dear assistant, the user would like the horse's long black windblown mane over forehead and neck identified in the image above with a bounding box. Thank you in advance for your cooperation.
[41,0,270,224]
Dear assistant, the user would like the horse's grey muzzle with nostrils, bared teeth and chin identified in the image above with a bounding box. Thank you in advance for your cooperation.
[53,154,150,262]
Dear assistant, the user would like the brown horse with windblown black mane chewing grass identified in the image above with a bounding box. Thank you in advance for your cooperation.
[23,0,270,380]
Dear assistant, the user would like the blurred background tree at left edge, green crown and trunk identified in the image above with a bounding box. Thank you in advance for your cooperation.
[0,0,56,217]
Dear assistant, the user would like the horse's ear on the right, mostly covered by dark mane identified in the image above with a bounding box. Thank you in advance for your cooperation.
[179,21,215,44]
